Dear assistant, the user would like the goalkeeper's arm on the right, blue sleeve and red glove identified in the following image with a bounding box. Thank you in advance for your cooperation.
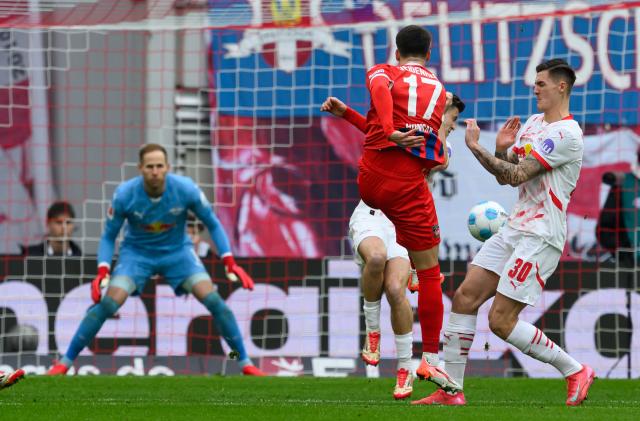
[191,185,253,290]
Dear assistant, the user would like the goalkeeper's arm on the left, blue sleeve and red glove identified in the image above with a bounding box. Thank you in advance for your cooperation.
[91,190,126,304]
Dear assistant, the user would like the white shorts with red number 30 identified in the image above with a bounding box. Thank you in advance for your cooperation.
[471,225,562,305]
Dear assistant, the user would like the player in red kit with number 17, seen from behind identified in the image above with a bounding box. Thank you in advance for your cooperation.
[358,25,460,391]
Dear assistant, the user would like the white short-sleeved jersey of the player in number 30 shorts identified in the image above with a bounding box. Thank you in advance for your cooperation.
[508,114,584,250]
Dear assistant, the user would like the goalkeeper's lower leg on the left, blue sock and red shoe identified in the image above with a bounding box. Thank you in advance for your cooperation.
[47,295,120,376]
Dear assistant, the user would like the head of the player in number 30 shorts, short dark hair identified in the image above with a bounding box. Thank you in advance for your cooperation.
[533,58,576,113]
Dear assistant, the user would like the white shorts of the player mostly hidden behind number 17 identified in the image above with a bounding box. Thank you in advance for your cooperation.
[349,200,409,266]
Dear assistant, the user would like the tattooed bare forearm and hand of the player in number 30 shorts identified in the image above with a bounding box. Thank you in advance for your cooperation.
[465,119,547,187]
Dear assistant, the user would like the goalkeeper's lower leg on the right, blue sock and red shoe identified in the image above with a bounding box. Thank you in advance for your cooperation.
[202,291,265,376]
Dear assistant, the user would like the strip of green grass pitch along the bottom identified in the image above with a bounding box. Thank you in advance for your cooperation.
[0,376,640,421]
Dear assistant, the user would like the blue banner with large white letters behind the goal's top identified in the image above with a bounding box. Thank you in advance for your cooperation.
[210,0,640,125]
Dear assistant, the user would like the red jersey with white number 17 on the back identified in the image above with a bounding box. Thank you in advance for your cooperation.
[364,63,446,165]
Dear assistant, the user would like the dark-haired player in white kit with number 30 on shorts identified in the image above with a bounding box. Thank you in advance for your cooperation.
[414,59,595,406]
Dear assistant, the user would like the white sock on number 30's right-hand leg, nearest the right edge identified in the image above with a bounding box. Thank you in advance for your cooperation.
[507,320,582,377]
